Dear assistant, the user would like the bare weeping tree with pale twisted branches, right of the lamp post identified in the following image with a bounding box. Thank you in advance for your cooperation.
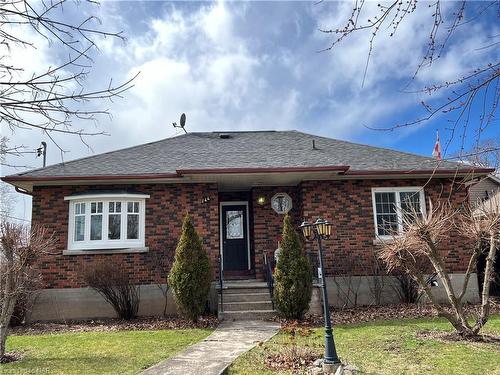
[380,202,500,337]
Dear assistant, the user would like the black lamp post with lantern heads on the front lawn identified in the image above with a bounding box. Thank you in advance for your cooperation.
[300,218,340,364]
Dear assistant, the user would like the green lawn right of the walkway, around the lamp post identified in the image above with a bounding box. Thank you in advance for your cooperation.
[229,316,500,375]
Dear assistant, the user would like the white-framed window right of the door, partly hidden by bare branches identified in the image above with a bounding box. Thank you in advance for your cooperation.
[372,187,425,238]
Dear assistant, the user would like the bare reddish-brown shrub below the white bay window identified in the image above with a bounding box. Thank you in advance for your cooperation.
[83,262,139,320]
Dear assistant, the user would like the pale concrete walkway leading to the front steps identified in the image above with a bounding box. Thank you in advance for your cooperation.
[141,321,279,375]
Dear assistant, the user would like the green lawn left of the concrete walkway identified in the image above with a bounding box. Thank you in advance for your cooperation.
[0,329,212,375]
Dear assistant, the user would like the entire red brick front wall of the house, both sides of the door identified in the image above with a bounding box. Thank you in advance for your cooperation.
[33,179,467,288]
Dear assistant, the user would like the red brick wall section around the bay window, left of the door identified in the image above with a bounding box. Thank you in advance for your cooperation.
[32,184,219,288]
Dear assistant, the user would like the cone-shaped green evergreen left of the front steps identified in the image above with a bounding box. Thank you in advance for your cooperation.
[168,215,212,321]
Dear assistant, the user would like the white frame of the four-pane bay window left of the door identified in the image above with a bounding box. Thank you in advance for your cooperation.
[64,194,149,251]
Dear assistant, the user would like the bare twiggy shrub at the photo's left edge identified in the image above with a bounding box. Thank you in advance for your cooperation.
[0,220,54,362]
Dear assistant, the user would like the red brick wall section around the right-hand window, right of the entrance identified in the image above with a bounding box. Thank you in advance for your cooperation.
[299,179,468,275]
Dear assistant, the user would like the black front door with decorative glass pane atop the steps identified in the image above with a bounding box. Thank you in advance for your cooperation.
[221,204,248,271]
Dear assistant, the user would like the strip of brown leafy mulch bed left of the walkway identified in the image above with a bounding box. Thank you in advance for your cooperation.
[11,316,219,335]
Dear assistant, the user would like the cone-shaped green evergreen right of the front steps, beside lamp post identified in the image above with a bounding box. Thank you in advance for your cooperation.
[274,215,313,319]
